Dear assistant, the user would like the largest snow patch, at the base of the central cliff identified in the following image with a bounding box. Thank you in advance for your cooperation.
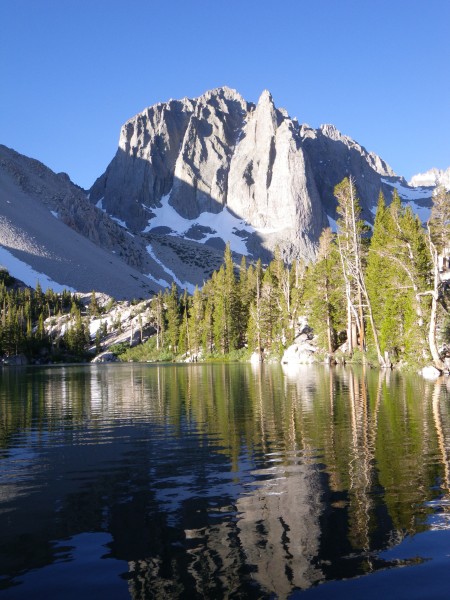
[143,192,256,255]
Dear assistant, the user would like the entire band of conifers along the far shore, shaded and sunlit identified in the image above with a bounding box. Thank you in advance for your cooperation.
[0,178,450,370]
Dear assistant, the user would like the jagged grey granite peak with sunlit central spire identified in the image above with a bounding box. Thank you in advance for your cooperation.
[90,87,402,260]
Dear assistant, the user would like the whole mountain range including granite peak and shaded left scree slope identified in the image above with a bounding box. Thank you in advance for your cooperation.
[0,87,445,298]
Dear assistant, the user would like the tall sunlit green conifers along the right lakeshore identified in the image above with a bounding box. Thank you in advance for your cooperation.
[145,178,450,368]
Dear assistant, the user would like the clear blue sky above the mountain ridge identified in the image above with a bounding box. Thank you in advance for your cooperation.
[0,0,450,188]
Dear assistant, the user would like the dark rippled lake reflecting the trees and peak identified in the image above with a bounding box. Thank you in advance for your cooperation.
[0,364,450,600]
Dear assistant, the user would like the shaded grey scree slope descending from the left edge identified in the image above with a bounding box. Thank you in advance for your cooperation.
[0,146,161,298]
